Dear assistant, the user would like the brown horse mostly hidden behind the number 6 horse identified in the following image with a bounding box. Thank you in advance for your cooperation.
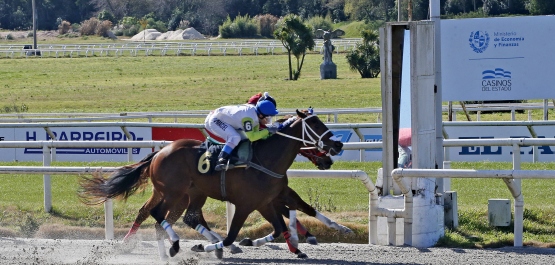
[123,147,351,260]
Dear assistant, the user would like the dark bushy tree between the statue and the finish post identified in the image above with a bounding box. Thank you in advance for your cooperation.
[346,30,380,78]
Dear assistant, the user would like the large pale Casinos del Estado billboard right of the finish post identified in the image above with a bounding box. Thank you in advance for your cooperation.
[446,16,555,101]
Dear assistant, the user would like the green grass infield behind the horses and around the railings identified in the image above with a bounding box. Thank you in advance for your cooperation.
[0,38,555,247]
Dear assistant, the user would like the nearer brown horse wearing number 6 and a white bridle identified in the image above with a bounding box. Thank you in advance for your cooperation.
[81,111,343,256]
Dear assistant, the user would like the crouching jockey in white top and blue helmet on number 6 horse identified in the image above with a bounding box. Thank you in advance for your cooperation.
[204,96,279,171]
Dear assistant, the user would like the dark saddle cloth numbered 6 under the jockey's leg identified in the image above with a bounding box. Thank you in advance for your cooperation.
[197,137,252,174]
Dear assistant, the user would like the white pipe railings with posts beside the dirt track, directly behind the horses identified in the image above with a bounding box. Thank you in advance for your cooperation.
[0,138,555,246]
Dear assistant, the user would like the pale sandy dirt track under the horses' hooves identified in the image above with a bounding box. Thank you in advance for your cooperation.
[0,237,555,265]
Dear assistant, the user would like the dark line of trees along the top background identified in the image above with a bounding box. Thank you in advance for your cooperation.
[0,0,555,35]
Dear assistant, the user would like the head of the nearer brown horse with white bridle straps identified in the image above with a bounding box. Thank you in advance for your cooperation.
[297,110,343,156]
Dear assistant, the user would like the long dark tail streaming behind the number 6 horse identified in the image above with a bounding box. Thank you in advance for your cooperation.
[78,151,158,205]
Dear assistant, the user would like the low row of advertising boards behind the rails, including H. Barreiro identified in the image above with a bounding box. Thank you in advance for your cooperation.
[0,125,555,162]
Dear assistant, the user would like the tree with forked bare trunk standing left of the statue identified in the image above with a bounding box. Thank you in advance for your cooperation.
[274,14,316,80]
